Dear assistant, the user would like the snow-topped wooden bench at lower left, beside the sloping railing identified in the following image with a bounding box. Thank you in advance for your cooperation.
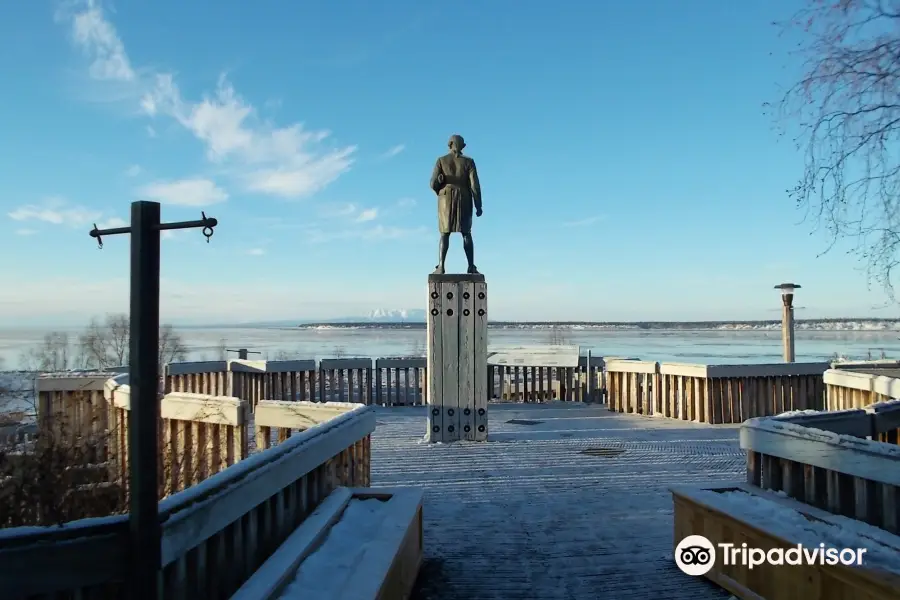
[232,488,423,600]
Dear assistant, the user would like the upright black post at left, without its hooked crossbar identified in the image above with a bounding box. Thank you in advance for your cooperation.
[128,202,161,600]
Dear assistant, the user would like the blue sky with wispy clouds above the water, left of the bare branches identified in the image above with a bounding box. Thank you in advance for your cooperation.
[0,0,896,325]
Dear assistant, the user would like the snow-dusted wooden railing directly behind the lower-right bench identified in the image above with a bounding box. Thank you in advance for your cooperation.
[741,401,900,533]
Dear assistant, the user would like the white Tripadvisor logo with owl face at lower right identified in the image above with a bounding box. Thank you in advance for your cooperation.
[675,535,866,577]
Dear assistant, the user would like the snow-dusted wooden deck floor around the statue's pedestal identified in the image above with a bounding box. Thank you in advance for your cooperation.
[372,402,746,600]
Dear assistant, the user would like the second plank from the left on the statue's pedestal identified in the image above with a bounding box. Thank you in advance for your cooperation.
[441,281,460,442]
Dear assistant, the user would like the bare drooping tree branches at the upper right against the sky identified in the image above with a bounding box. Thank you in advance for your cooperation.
[773,0,900,299]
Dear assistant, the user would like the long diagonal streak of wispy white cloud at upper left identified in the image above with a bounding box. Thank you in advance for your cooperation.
[61,0,356,198]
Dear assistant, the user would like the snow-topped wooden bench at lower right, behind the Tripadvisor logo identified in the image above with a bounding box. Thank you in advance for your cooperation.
[672,484,900,600]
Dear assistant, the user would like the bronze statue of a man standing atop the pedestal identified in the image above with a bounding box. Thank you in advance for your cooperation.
[431,135,482,275]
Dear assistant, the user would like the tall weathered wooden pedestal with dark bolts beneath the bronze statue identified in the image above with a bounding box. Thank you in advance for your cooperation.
[426,275,488,442]
